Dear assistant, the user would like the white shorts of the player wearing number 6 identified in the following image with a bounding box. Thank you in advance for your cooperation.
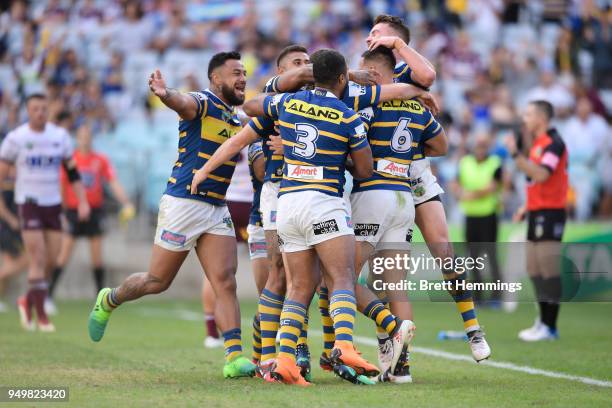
[351,190,414,250]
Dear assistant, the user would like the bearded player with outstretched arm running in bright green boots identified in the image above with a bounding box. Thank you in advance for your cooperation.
[89,52,255,378]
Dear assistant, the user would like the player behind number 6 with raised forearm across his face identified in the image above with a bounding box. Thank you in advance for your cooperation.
[366,15,491,361]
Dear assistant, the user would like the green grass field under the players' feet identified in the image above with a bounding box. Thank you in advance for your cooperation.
[0,299,612,408]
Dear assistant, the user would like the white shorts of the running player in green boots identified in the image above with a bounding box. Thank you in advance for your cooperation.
[155,194,236,252]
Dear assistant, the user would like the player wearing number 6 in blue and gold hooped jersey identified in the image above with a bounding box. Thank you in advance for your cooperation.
[351,47,446,382]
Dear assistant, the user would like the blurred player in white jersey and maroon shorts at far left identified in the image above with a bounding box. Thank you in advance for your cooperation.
[0,94,90,332]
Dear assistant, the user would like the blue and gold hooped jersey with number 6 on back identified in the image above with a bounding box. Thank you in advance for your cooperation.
[353,99,442,192]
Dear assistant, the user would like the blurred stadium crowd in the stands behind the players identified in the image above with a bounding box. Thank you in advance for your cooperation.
[0,0,612,220]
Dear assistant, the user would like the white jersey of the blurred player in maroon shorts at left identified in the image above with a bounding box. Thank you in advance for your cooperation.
[0,123,73,206]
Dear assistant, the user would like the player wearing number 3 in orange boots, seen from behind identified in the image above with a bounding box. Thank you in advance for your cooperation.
[238,50,378,385]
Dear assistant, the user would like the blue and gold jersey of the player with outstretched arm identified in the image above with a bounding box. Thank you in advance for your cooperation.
[165,89,241,205]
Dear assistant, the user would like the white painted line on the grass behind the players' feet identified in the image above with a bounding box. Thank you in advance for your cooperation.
[140,308,612,387]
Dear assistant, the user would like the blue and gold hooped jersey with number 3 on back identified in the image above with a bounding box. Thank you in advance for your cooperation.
[264,89,368,197]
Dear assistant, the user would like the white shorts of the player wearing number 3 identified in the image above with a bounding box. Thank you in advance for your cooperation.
[277,191,354,252]
